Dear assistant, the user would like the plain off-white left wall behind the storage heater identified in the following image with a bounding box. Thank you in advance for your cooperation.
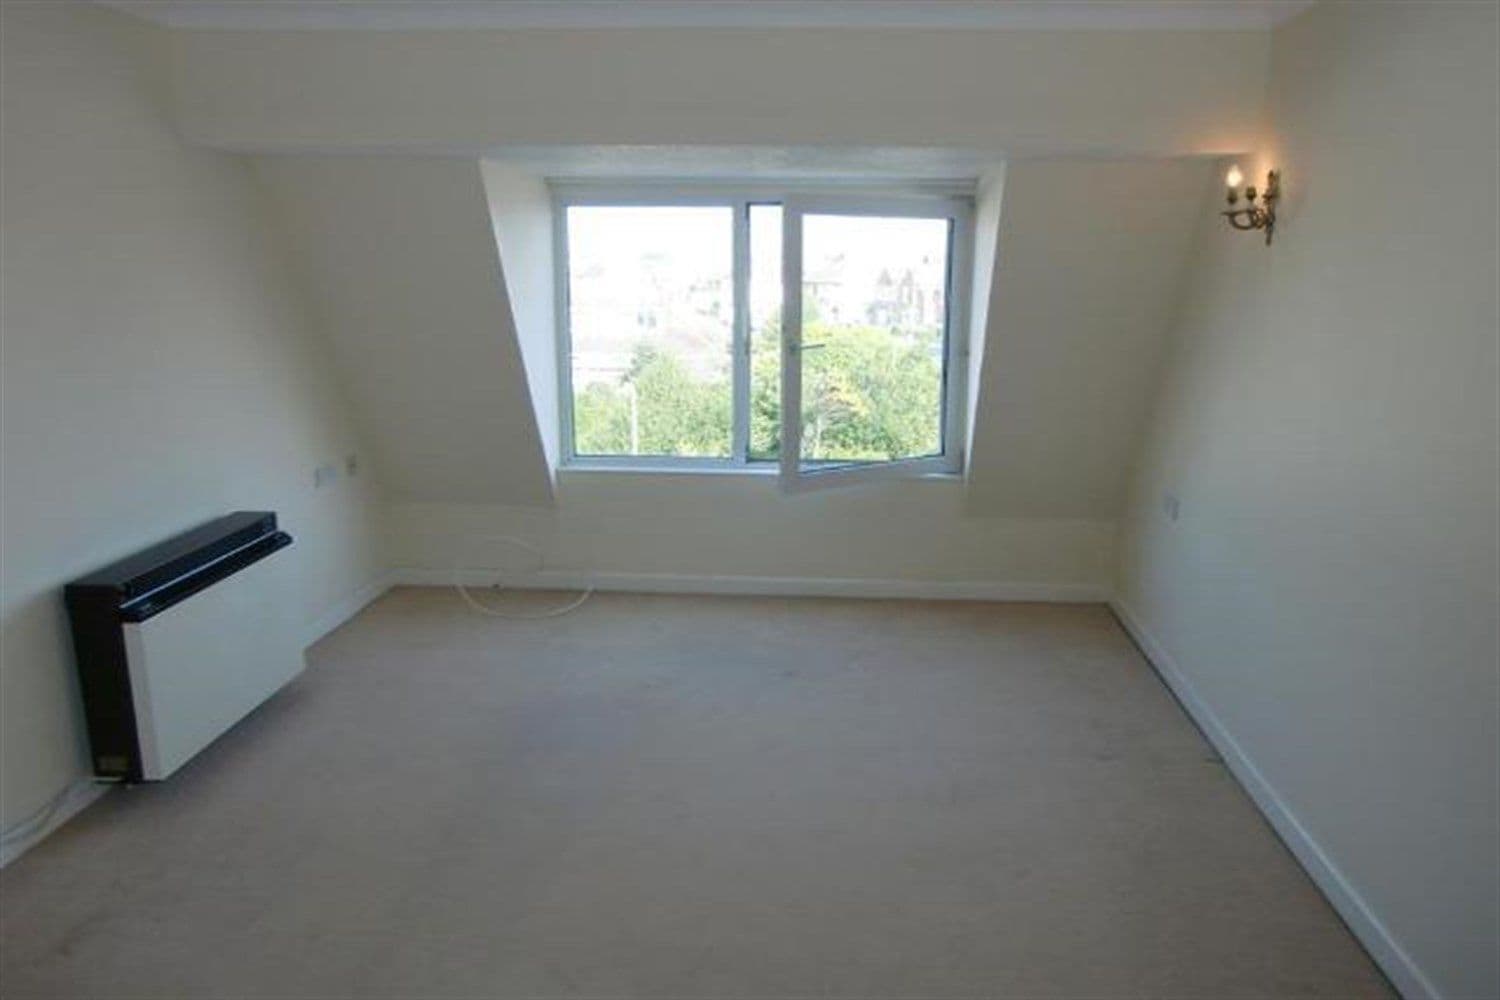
[0,3,378,828]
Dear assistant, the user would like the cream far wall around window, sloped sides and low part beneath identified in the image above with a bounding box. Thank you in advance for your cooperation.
[261,154,1212,597]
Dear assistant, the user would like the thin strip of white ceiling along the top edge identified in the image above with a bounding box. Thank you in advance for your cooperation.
[99,0,1311,30]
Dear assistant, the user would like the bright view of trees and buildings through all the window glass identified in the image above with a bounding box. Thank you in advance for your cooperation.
[567,204,948,462]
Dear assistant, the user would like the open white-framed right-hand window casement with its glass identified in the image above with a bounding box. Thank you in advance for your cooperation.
[780,196,971,492]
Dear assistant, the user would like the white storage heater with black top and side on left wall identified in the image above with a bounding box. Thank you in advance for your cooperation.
[63,511,303,781]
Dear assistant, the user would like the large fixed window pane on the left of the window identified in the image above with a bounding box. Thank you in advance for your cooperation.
[567,205,734,457]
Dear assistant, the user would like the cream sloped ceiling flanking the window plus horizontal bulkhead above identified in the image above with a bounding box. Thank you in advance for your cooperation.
[149,7,1269,519]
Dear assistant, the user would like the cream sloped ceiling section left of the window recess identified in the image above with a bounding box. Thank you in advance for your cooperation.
[257,156,552,505]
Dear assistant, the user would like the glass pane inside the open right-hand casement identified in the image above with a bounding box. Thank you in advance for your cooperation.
[801,214,950,462]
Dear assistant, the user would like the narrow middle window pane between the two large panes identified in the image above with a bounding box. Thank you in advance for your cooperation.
[750,205,782,462]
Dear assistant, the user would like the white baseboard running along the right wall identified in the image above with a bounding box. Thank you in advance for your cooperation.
[1109,597,1442,1000]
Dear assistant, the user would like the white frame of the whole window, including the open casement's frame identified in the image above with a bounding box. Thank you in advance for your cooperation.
[549,180,974,492]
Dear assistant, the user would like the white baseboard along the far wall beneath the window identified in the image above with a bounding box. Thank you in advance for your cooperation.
[392,567,1109,604]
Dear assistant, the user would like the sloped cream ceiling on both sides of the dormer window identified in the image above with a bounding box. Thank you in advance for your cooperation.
[260,156,1214,519]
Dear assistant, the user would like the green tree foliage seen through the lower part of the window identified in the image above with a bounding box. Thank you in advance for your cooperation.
[575,319,942,462]
